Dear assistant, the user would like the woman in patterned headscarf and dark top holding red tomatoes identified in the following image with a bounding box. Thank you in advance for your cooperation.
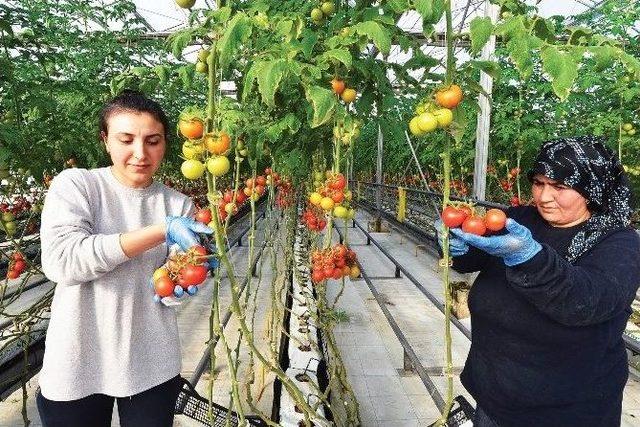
[450,137,640,427]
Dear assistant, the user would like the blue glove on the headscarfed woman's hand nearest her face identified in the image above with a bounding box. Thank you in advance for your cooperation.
[451,218,542,267]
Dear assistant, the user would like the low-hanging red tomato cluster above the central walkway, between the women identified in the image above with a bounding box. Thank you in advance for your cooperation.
[311,244,360,283]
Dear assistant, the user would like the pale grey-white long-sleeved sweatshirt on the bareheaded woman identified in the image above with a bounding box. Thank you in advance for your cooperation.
[39,168,193,401]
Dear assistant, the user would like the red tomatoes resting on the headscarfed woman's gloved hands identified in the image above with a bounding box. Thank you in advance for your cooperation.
[441,204,507,236]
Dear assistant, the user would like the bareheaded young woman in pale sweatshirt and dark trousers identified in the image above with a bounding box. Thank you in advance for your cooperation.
[37,92,212,427]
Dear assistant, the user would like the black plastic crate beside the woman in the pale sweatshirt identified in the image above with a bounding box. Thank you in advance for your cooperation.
[175,378,267,427]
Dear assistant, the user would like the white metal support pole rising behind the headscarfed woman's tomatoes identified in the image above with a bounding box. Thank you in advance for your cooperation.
[473,0,500,200]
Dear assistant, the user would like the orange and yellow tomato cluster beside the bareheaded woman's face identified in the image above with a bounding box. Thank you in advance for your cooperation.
[178,116,232,179]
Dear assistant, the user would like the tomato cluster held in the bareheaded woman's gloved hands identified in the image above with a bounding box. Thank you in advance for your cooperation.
[153,245,209,301]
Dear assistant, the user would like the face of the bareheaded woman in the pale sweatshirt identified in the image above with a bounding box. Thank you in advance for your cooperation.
[104,111,167,188]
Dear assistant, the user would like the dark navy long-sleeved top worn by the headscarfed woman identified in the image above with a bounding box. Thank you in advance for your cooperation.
[453,206,640,427]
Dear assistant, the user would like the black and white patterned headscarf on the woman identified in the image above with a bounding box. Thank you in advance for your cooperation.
[528,136,632,262]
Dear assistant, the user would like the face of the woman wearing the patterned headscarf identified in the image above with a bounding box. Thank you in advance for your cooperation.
[531,174,591,227]
